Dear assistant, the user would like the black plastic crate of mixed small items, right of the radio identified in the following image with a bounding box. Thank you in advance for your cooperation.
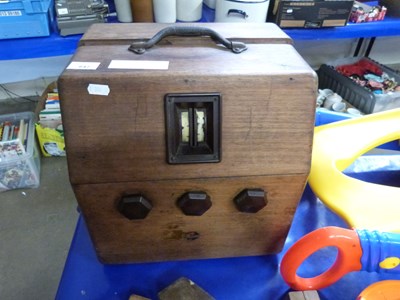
[317,57,400,114]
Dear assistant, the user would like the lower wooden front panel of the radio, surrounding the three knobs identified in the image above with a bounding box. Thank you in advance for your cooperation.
[74,175,306,263]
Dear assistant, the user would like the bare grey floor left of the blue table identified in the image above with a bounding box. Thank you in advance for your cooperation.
[0,100,78,300]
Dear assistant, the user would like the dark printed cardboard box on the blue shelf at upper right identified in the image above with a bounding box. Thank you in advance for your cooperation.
[273,0,354,28]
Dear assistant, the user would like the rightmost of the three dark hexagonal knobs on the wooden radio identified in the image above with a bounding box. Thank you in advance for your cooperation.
[234,189,267,213]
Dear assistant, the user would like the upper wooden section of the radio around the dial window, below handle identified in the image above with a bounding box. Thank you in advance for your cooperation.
[59,39,316,183]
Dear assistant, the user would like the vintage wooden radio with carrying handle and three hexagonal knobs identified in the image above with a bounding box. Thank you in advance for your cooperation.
[58,23,317,263]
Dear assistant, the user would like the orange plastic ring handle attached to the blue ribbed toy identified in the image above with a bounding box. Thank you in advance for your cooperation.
[280,226,362,290]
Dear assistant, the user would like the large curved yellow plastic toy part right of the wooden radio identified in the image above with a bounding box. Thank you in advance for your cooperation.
[309,109,400,233]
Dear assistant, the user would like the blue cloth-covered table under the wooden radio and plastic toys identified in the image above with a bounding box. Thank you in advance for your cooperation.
[56,149,400,300]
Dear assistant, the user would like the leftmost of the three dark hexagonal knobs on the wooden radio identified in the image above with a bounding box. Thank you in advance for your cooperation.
[118,194,153,220]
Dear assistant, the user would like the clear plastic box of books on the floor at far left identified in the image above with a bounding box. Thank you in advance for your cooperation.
[0,112,40,192]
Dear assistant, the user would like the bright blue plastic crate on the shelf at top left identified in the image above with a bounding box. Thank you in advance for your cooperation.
[0,0,54,39]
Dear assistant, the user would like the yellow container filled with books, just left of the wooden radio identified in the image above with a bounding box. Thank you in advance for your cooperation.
[35,83,65,157]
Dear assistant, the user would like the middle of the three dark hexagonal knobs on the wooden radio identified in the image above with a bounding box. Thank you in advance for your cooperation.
[177,192,212,216]
